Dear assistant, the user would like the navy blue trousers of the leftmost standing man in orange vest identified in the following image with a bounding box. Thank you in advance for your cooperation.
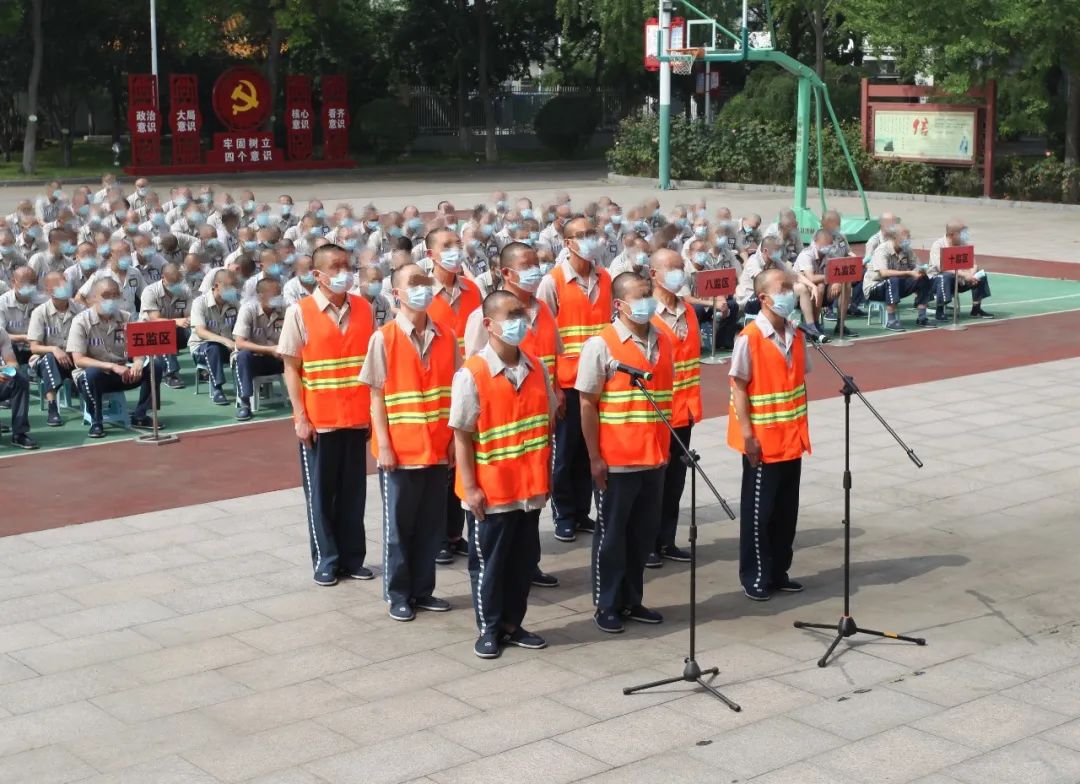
[300,428,367,575]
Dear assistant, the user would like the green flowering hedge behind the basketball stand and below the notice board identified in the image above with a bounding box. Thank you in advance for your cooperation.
[607,116,1080,203]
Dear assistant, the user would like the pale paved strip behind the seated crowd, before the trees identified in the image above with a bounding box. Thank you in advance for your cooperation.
[0,164,1080,261]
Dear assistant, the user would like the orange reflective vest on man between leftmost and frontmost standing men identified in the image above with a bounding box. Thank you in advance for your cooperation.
[372,322,457,465]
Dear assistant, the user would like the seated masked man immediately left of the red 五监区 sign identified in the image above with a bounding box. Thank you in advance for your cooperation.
[67,278,165,438]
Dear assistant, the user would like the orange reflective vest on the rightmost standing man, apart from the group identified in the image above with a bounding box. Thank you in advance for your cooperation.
[728,322,810,463]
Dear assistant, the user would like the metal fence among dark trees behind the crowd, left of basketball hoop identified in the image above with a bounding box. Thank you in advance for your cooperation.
[408,87,629,136]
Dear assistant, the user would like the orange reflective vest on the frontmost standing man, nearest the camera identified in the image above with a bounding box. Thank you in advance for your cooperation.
[454,354,551,508]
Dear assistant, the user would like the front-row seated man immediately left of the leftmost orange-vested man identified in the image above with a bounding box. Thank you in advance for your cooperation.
[232,278,285,422]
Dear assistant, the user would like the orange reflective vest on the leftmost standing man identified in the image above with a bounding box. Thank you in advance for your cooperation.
[300,294,373,430]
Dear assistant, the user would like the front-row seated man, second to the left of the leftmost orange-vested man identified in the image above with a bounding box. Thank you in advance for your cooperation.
[188,268,240,406]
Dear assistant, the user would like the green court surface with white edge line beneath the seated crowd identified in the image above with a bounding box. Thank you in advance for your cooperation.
[0,273,1080,458]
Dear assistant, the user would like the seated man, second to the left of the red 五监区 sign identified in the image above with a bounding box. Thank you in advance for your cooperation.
[27,272,83,428]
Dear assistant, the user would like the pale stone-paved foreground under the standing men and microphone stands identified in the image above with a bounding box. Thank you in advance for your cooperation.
[0,360,1080,784]
